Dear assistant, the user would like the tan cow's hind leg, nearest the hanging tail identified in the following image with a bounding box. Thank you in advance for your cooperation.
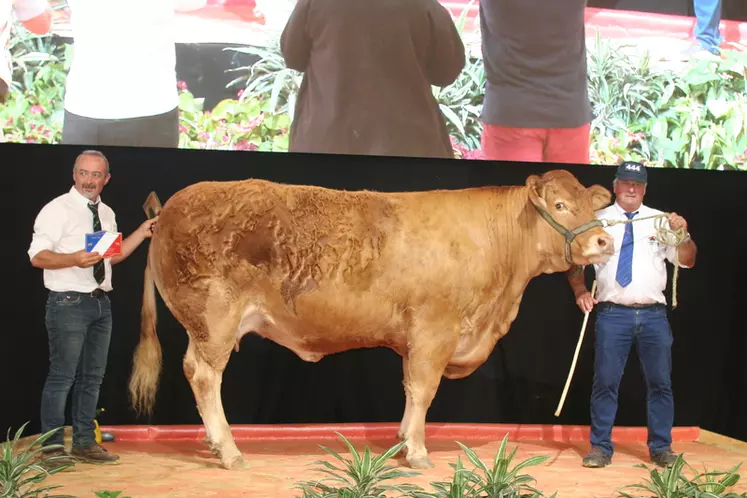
[184,338,244,470]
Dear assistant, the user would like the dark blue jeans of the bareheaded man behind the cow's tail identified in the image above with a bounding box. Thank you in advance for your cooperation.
[41,292,112,448]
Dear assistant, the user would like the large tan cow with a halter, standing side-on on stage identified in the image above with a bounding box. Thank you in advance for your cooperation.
[130,170,613,468]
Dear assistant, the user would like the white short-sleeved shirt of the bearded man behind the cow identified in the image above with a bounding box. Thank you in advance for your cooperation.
[28,186,117,292]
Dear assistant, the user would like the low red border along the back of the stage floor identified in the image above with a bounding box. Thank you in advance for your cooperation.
[101,423,700,443]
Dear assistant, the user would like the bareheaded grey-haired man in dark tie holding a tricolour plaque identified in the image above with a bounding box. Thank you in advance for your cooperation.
[28,151,158,462]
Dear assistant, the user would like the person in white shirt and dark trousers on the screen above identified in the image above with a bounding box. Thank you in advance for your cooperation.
[62,0,206,147]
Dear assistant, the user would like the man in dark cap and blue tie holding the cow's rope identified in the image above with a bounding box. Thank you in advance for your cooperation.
[568,161,697,467]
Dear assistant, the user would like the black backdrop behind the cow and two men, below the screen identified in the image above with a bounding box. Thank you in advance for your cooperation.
[0,144,747,446]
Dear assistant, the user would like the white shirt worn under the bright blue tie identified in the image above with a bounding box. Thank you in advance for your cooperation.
[594,202,687,306]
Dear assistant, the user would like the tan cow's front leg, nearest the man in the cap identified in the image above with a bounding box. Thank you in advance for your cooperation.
[400,324,459,469]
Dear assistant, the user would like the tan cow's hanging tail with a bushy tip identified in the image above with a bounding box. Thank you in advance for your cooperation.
[130,258,161,415]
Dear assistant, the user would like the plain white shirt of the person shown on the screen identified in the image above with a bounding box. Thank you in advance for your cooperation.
[65,0,179,119]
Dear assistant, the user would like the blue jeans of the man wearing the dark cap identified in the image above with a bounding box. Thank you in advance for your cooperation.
[591,303,674,456]
